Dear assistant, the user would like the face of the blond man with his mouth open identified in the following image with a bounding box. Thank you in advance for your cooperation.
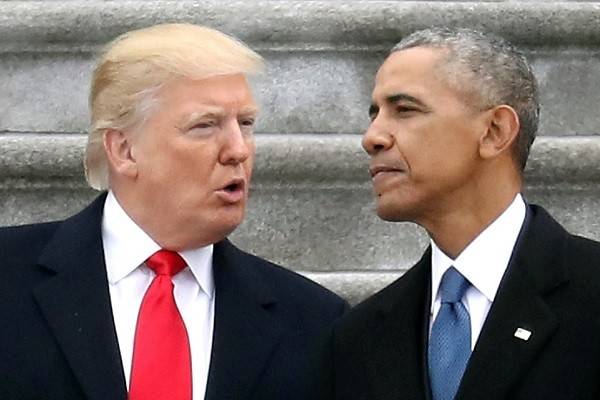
[126,74,257,249]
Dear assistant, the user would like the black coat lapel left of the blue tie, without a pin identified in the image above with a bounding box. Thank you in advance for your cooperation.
[363,250,431,400]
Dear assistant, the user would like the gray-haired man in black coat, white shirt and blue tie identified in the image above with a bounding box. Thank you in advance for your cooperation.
[320,28,600,400]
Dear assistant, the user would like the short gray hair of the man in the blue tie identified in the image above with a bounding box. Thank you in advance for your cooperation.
[391,28,539,170]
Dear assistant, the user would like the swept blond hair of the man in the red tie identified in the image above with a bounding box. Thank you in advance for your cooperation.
[84,24,263,190]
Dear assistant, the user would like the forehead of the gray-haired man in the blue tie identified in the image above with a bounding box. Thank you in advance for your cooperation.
[373,47,449,102]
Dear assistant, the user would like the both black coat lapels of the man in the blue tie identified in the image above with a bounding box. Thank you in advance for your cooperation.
[362,206,569,400]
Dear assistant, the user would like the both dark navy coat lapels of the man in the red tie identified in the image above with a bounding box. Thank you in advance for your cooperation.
[34,194,282,400]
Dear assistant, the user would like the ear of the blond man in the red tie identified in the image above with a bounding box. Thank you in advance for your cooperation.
[103,129,137,178]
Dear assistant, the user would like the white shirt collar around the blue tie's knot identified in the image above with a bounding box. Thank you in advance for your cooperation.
[431,194,526,304]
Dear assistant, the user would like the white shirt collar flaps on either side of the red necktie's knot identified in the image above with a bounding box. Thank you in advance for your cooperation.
[102,191,214,298]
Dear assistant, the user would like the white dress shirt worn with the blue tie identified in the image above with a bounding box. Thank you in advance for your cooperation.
[429,194,525,350]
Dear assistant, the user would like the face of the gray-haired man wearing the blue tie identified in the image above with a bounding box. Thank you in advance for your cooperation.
[362,47,486,224]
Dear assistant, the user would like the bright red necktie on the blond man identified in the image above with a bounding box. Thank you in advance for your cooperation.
[129,250,192,400]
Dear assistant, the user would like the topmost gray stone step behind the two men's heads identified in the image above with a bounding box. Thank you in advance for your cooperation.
[0,1,600,136]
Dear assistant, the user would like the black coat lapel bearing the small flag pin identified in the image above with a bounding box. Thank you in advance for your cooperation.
[457,207,568,400]
